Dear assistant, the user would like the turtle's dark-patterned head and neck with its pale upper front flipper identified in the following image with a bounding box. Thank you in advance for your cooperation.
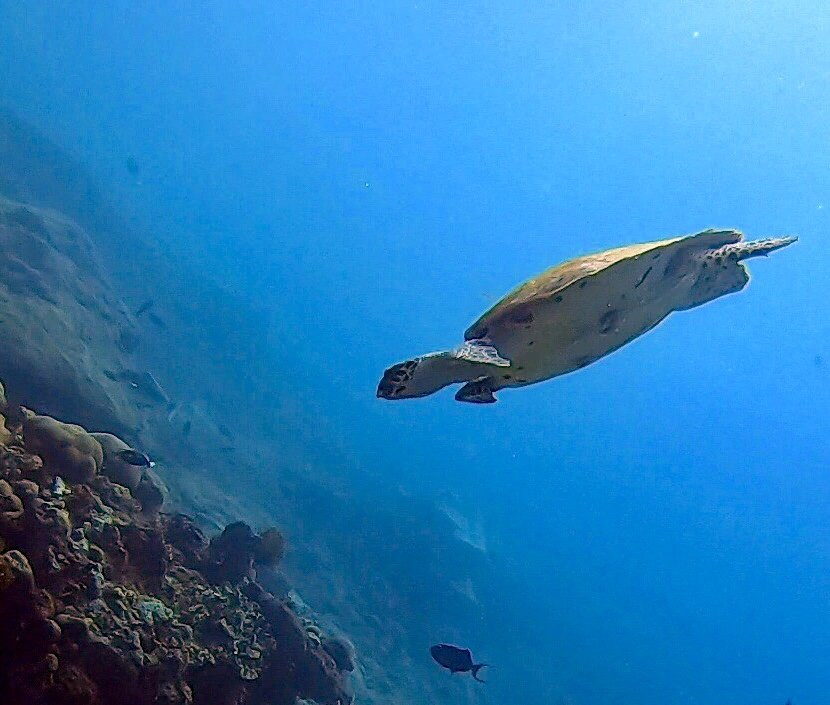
[377,341,510,401]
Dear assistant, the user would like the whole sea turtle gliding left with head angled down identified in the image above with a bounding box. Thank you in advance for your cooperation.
[377,229,797,404]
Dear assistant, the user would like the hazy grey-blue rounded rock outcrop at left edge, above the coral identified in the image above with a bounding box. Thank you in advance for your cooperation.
[0,196,148,430]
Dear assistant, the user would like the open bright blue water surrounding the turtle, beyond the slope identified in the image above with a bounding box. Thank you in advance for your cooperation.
[0,0,830,705]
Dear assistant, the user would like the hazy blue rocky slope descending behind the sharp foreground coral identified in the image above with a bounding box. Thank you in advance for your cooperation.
[0,110,508,705]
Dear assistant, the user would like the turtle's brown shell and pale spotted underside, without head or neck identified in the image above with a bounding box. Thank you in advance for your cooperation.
[464,230,748,386]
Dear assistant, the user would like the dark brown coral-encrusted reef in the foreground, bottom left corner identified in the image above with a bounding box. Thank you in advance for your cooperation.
[0,394,354,705]
